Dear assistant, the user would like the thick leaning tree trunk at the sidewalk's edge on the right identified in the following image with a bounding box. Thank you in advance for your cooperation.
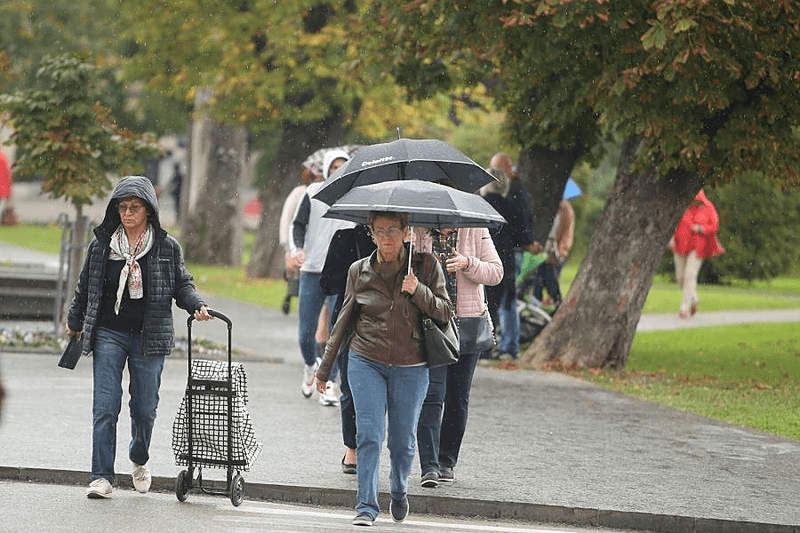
[522,139,700,368]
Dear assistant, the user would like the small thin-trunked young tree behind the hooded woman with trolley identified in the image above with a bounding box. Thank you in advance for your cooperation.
[0,56,157,286]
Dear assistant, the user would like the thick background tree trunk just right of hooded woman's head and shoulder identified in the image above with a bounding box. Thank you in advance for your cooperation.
[181,118,248,265]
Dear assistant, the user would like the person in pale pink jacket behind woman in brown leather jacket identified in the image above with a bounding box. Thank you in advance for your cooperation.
[414,224,503,488]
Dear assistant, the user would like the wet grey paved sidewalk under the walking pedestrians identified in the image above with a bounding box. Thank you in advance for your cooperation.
[0,246,800,533]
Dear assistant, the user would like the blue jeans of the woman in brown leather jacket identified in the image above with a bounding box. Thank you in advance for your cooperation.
[347,350,428,519]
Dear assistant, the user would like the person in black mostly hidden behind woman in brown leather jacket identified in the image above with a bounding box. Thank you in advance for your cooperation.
[319,224,375,474]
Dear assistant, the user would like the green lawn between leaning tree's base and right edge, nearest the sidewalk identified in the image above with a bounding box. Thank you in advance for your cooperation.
[577,323,800,440]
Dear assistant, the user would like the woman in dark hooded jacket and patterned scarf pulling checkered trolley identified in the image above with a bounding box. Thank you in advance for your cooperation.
[67,176,211,498]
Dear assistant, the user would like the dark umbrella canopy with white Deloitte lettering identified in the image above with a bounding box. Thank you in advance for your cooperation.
[314,139,495,205]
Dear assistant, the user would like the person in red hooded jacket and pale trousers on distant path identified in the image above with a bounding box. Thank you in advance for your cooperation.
[669,189,725,318]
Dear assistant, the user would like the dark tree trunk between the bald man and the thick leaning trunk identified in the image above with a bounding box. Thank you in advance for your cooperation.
[517,146,583,244]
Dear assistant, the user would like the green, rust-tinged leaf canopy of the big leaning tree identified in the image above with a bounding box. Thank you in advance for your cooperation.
[384,0,800,184]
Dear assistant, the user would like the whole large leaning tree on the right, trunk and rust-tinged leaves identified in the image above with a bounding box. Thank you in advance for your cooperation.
[376,0,800,367]
